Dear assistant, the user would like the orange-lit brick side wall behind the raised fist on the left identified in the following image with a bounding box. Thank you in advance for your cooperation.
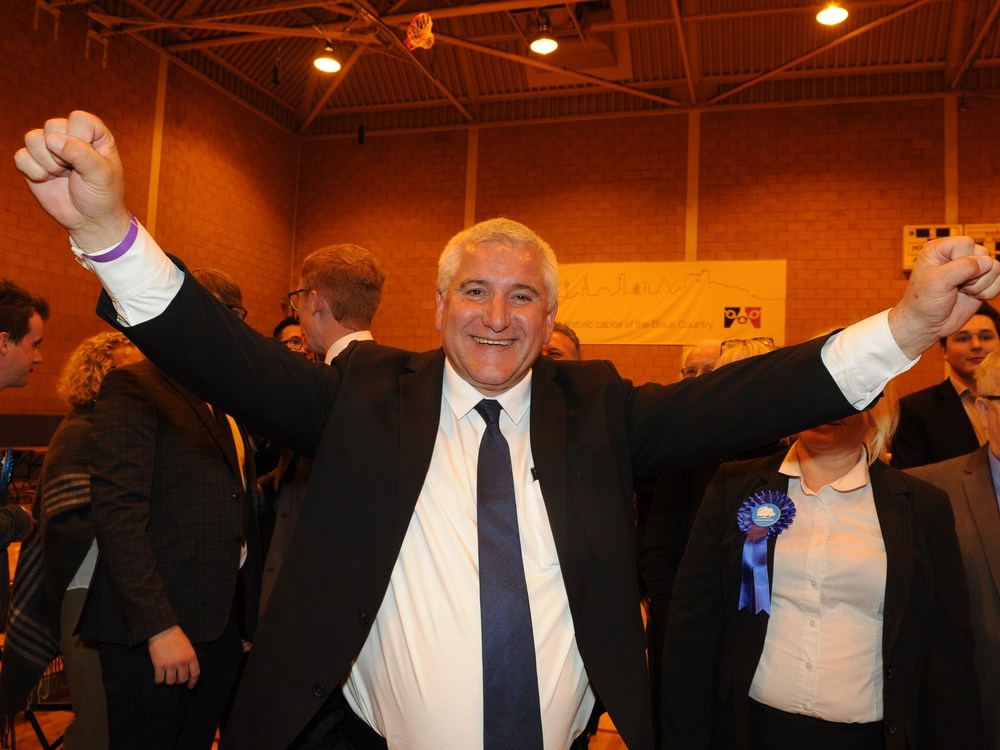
[0,2,298,414]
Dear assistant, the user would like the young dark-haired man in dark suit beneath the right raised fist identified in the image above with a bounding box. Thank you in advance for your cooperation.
[892,302,1000,469]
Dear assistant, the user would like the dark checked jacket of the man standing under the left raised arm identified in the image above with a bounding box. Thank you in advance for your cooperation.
[81,362,260,646]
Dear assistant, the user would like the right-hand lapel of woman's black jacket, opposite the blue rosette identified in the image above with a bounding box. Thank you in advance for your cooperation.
[869,461,913,653]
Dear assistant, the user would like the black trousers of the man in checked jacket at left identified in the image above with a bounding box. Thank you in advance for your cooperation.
[100,617,243,750]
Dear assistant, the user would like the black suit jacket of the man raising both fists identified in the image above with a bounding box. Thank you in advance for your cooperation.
[100,268,868,750]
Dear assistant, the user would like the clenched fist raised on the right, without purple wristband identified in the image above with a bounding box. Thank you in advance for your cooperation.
[889,237,1000,359]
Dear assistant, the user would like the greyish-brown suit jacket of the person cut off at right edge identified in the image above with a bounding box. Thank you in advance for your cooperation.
[910,446,1000,750]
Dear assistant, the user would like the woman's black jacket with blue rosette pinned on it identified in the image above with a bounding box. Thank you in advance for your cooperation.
[663,456,982,750]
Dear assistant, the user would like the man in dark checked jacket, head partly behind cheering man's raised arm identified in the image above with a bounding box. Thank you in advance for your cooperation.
[80,269,260,750]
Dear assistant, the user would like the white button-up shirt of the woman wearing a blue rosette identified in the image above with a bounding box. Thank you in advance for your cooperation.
[750,444,886,724]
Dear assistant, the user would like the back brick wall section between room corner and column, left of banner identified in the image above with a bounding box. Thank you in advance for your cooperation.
[296,131,468,351]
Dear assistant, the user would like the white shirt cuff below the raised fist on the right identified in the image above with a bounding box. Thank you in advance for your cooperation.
[822,310,920,409]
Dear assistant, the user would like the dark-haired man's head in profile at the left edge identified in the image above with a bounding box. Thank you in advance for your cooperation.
[0,279,49,390]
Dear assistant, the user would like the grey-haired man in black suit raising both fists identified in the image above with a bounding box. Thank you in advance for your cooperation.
[16,113,1000,750]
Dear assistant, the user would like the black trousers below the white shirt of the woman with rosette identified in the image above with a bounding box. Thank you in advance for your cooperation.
[747,700,885,750]
